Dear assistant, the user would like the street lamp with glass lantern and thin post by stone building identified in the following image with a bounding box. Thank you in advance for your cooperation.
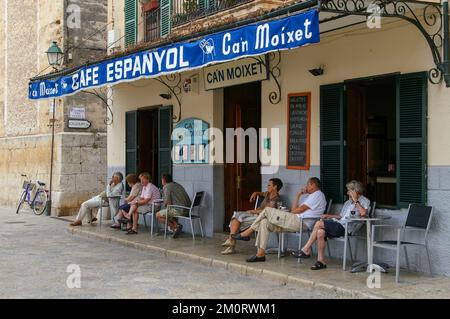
[45,41,64,216]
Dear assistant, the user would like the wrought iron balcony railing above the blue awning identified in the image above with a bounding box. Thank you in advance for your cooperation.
[172,0,253,27]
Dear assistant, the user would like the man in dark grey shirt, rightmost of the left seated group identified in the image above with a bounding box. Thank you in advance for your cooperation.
[156,174,191,238]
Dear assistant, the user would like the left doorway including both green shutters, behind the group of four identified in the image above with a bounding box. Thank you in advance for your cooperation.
[125,106,172,186]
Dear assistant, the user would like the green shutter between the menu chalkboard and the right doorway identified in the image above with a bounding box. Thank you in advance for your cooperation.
[320,84,344,203]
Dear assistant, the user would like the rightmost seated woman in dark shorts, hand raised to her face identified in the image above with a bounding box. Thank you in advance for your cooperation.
[293,180,370,270]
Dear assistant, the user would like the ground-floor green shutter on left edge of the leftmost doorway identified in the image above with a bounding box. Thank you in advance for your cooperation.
[125,111,138,179]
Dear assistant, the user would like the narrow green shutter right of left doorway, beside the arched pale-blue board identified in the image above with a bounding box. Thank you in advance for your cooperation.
[158,106,172,186]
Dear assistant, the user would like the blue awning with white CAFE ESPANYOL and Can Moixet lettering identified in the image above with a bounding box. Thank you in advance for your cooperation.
[29,10,320,100]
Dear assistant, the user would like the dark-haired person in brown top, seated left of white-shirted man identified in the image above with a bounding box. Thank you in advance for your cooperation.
[222,178,283,255]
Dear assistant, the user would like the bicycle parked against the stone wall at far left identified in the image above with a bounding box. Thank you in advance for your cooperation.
[16,174,48,215]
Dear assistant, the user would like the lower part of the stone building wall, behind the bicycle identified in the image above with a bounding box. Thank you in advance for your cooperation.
[0,133,106,216]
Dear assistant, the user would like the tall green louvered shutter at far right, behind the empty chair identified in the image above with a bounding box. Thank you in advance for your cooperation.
[397,72,428,207]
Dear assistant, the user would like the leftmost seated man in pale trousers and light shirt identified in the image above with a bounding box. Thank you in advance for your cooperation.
[70,172,123,226]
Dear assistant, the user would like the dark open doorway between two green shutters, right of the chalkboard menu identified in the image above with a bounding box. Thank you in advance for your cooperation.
[345,77,397,207]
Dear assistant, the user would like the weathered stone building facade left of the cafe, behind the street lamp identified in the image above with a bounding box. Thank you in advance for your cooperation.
[0,0,107,216]
